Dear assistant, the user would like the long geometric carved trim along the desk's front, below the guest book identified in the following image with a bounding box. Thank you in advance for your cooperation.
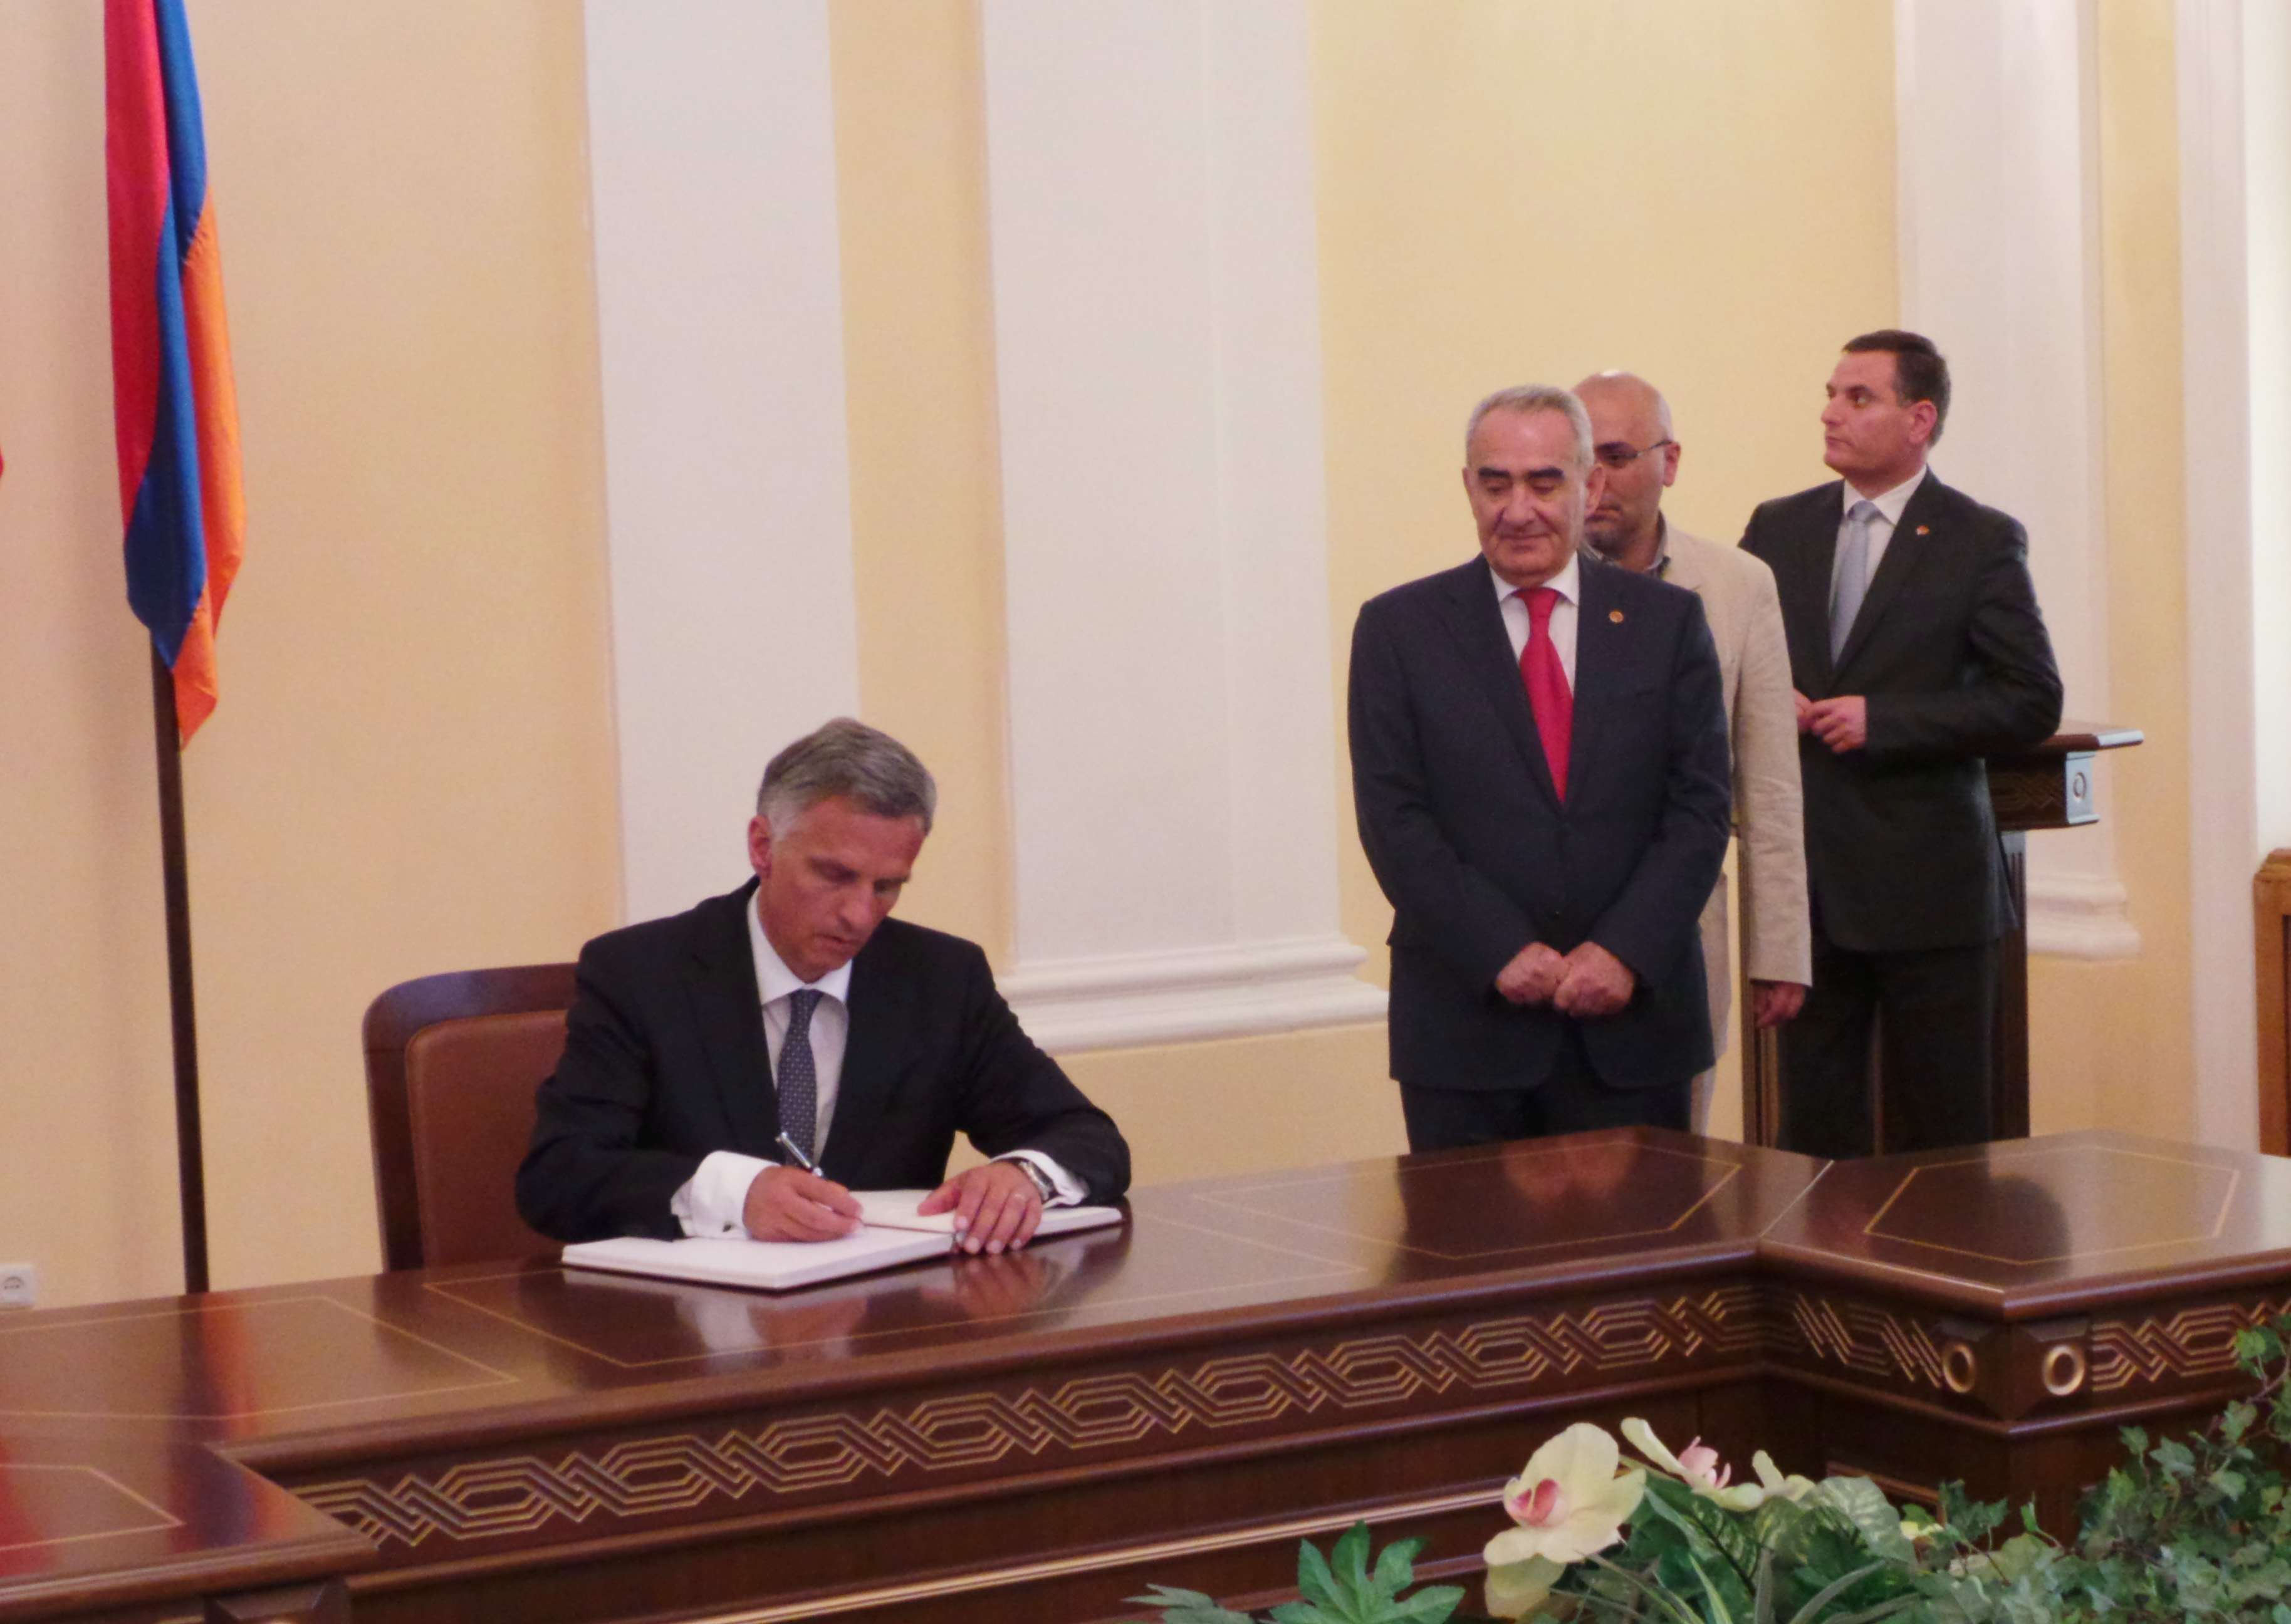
[296,1283,1764,1551]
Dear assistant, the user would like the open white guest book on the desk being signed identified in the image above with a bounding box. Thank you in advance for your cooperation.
[563,1189,1122,1292]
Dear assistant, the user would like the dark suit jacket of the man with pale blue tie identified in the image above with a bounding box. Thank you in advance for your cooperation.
[1741,474,2060,953]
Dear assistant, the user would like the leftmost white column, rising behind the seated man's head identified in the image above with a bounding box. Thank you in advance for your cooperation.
[587,0,859,919]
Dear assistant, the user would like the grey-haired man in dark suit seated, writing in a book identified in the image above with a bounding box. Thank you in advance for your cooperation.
[518,719,1129,1253]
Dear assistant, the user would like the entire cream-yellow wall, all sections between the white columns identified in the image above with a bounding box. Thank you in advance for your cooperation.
[0,0,2218,1301]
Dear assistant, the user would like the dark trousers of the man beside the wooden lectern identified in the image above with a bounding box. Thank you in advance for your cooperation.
[1782,907,1995,1159]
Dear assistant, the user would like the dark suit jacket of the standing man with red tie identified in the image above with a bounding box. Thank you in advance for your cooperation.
[1352,556,1730,1088]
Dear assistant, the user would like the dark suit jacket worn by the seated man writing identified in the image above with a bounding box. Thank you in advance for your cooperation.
[518,882,1129,1241]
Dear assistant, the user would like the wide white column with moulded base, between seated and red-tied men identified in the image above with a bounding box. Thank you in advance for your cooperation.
[983,0,1384,1049]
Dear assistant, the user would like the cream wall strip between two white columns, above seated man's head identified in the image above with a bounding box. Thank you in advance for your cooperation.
[827,0,1010,962]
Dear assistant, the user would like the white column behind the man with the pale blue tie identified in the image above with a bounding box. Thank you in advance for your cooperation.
[1895,0,2135,957]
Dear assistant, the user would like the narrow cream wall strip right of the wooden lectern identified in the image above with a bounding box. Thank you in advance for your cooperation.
[2030,0,2194,1138]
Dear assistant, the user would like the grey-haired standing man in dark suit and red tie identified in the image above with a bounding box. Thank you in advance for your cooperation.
[1349,387,1730,1150]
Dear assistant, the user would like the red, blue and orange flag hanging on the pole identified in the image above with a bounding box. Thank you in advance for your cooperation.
[103,0,245,742]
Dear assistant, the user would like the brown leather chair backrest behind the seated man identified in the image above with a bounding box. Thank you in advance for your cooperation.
[367,964,573,1269]
